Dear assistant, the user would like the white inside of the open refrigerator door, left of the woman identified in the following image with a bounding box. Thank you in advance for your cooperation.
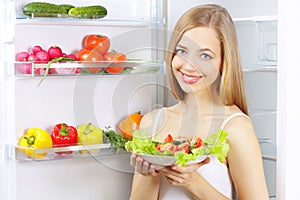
[0,0,163,200]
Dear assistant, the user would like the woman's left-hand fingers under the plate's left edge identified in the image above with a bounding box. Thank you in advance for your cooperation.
[130,154,163,176]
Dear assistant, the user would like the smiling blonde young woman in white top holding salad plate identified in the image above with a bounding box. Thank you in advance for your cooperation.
[127,5,269,200]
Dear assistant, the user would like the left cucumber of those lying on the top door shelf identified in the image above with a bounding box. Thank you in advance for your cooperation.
[23,2,68,17]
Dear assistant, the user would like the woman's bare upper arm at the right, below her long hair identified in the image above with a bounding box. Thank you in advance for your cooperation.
[225,116,269,200]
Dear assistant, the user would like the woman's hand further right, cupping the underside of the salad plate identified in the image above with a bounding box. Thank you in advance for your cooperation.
[159,157,210,186]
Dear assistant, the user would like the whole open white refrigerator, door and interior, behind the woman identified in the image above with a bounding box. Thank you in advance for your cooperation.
[0,0,277,200]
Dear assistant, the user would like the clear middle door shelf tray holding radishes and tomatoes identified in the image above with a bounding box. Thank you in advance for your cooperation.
[14,60,165,77]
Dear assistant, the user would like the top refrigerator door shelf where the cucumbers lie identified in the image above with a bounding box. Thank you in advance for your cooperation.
[15,0,164,24]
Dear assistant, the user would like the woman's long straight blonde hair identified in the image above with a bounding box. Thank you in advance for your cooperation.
[166,4,248,114]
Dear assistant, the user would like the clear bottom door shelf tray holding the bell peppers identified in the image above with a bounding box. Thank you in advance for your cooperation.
[9,143,128,161]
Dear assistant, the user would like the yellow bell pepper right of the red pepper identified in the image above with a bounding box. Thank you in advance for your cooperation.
[77,123,103,152]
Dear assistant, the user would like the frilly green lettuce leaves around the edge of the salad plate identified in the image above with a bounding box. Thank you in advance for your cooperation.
[125,129,229,166]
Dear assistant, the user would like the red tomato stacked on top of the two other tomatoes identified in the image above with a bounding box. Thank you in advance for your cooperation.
[84,34,110,54]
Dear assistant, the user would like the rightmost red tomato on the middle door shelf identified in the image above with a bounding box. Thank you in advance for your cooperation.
[103,51,127,74]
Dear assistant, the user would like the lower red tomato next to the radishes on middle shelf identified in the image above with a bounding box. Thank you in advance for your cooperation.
[77,48,103,73]
